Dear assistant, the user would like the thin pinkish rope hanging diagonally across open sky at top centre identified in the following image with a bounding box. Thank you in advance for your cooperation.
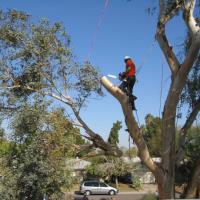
[85,0,109,62]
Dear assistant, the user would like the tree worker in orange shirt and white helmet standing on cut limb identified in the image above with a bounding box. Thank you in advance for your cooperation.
[119,56,137,110]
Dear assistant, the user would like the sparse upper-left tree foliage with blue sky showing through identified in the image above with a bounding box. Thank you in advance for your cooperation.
[0,10,102,111]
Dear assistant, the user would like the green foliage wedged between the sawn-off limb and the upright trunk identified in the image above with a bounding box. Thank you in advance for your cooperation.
[141,114,162,156]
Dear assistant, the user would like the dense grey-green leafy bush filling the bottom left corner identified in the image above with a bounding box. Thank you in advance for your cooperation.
[0,141,72,200]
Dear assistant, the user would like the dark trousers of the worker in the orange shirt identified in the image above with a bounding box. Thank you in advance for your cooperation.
[119,76,136,97]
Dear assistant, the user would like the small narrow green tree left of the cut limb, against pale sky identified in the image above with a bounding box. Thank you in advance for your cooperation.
[108,121,122,147]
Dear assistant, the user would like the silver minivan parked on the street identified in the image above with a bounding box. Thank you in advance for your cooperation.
[80,181,118,195]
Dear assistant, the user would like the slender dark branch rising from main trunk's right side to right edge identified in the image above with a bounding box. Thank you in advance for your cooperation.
[176,99,200,165]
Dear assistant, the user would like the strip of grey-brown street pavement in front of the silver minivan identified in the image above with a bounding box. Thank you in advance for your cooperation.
[74,193,144,200]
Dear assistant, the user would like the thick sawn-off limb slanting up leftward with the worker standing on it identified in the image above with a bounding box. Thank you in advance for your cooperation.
[101,76,166,199]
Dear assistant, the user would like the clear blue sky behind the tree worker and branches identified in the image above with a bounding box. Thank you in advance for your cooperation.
[0,0,189,147]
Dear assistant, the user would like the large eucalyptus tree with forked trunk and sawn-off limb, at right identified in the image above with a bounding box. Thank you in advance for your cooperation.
[101,0,200,199]
